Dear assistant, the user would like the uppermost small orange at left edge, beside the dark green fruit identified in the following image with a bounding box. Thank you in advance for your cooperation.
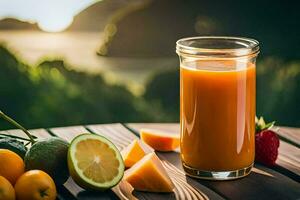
[0,149,25,185]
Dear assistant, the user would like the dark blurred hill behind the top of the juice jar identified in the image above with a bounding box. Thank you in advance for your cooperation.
[98,0,300,59]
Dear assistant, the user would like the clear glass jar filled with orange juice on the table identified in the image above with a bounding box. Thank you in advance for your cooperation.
[176,37,259,180]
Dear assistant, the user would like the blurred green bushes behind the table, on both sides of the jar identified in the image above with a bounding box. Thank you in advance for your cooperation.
[0,46,300,130]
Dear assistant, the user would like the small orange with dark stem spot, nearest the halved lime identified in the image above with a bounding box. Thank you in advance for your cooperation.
[15,170,57,200]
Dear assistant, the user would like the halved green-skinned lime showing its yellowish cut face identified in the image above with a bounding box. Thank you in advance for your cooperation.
[68,134,124,190]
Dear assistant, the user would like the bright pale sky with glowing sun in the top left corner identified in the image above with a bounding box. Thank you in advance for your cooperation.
[0,0,99,32]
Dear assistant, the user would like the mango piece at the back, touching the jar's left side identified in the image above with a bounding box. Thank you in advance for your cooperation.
[140,129,180,151]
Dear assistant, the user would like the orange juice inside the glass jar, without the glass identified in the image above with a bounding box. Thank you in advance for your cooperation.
[180,61,255,171]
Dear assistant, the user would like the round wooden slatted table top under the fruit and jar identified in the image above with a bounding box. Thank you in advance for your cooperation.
[2,124,300,200]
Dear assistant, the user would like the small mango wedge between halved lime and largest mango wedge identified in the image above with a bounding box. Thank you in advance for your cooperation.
[121,139,153,168]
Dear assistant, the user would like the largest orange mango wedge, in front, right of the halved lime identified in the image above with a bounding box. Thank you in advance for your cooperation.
[124,152,175,192]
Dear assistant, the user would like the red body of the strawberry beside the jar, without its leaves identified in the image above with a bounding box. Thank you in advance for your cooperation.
[255,129,279,166]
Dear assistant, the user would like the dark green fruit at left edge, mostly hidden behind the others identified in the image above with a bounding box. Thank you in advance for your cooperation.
[0,137,27,158]
